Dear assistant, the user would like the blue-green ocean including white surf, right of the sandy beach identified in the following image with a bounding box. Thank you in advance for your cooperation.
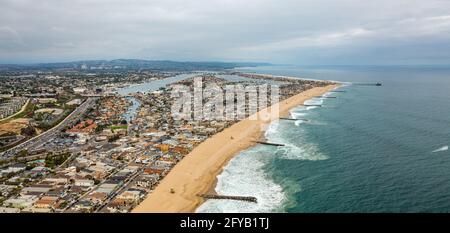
[197,66,450,213]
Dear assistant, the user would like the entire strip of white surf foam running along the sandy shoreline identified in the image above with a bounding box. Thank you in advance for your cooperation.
[196,95,328,213]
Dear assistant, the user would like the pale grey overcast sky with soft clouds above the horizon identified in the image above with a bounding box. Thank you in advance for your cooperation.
[0,0,450,64]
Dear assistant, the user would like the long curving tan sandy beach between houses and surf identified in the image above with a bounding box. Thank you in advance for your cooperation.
[132,84,338,213]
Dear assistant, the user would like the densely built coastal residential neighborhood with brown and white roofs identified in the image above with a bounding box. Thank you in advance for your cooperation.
[0,66,327,213]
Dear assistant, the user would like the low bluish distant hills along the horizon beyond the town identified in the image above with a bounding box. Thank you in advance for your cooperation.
[0,59,270,71]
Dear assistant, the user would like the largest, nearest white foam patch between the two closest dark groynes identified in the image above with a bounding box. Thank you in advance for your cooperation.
[197,146,286,213]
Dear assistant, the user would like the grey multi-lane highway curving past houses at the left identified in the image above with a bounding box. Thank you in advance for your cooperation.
[0,98,96,159]
